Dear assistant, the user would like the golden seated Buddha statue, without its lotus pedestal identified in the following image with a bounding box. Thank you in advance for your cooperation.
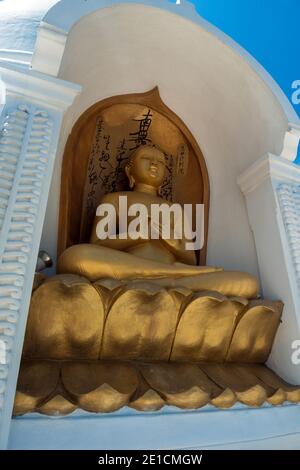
[57,145,259,299]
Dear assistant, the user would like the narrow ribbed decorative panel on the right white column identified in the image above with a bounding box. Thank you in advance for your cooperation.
[276,183,300,293]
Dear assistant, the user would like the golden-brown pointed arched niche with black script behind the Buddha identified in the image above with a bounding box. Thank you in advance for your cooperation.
[58,87,209,264]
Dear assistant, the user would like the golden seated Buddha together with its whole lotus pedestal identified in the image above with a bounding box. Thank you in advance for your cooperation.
[14,146,292,416]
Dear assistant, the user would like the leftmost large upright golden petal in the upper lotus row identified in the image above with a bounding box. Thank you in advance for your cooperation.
[23,275,104,359]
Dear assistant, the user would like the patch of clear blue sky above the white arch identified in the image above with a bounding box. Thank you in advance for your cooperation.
[174,0,300,121]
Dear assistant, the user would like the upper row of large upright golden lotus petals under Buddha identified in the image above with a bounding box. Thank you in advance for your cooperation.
[23,275,282,363]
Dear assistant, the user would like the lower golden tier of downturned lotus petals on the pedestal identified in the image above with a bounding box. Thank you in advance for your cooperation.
[14,360,300,416]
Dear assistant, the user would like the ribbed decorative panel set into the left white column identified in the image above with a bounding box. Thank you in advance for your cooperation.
[0,104,54,434]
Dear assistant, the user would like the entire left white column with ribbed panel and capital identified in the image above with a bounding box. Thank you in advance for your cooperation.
[0,62,80,448]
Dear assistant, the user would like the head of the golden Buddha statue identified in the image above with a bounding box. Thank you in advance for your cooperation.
[125,145,166,191]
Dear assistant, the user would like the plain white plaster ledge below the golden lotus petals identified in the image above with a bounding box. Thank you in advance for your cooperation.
[9,404,300,450]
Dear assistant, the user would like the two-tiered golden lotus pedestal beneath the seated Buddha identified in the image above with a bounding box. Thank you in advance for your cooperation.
[14,275,300,415]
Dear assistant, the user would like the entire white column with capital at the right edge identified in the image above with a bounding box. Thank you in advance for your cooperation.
[238,155,300,384]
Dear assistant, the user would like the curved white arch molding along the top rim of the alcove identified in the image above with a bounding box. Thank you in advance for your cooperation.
[32,0,300,154]
